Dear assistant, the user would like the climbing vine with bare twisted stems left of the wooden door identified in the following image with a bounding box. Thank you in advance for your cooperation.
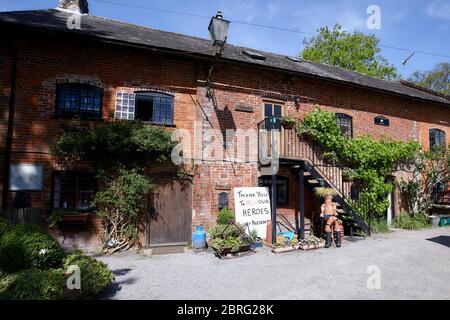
[51,121,181,253]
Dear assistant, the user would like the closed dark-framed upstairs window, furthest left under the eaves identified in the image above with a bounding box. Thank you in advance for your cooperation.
[56,83,103,119]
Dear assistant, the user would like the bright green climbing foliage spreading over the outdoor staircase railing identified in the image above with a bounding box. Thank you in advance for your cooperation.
[298,108,420,220]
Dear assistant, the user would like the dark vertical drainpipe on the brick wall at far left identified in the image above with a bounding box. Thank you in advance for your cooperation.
[2,46,17,211]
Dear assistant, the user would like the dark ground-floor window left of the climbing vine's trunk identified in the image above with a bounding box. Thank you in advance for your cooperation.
[52,171,97,210]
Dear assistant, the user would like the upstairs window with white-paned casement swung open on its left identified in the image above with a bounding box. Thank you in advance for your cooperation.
[116,92,174,124]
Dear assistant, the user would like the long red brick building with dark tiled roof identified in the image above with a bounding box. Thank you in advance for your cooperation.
[0,1,450,251]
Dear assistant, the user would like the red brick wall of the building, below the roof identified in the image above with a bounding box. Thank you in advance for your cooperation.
[0,29,450,248]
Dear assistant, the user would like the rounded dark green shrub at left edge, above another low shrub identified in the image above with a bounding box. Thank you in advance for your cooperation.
[0,225,64,273]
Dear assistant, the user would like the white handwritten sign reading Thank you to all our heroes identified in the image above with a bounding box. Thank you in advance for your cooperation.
[234,188,271,239]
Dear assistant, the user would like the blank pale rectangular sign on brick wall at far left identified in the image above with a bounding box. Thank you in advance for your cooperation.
[9,164,43,191]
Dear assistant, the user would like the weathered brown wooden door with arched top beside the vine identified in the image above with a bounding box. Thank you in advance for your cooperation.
[147,181,192,247]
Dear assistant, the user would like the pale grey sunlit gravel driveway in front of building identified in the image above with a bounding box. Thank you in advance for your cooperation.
[99,228,450,300]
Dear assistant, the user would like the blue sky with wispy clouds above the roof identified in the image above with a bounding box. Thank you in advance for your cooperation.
[0,0,450,77]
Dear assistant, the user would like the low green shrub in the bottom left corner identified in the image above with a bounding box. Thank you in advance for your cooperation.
[0,269,65,300]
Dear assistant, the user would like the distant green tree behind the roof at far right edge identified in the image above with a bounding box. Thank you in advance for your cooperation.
[408,62,450,95]
